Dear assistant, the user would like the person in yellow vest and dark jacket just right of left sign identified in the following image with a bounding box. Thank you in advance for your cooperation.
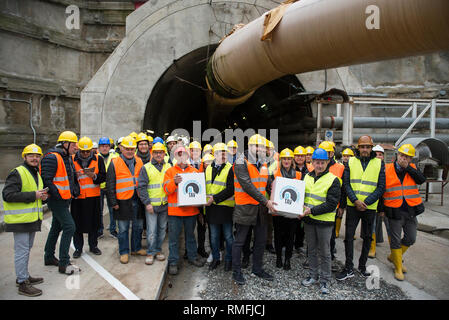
[205,143,235,271]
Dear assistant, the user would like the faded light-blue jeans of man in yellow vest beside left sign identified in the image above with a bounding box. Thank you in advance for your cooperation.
[145,206,168,256]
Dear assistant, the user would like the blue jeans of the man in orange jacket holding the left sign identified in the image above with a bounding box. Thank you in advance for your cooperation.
[168,215,197,265]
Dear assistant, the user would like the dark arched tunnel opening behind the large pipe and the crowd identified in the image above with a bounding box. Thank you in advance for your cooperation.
[143,44,312,149]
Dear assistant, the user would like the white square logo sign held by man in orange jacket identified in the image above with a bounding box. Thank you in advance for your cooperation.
[178,172,207,207]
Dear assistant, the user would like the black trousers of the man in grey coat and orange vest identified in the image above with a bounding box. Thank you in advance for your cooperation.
[232,215,267,273]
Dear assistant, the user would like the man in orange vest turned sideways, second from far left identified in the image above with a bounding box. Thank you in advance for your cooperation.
[41,131,81,275]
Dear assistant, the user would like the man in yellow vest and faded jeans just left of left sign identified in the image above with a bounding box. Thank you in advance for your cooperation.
[137,142,171,265]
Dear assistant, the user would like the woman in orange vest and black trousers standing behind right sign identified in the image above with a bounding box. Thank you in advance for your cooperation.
[268,148,301,270]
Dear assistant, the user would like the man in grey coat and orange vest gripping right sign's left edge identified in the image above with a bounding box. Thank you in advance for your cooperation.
[232,134,276,284]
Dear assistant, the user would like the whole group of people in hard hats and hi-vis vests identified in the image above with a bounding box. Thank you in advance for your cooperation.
[3,131,426,296]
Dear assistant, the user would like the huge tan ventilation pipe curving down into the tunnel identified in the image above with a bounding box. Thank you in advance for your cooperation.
[207,0,449,105]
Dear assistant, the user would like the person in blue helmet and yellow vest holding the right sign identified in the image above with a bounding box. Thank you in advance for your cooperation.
[299,148,341,294]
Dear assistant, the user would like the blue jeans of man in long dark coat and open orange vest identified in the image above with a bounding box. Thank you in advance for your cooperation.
[117,200,143,255]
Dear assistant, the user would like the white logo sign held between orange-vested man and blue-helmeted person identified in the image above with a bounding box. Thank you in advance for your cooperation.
[271,177,306,218]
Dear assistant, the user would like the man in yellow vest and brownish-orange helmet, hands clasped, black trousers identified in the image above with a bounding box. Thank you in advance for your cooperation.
[336,135,385,281]
